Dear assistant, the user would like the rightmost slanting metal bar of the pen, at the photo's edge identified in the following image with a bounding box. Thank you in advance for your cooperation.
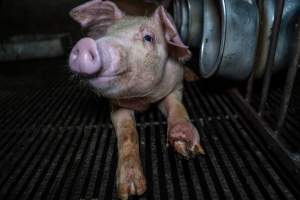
[276,19,300,131]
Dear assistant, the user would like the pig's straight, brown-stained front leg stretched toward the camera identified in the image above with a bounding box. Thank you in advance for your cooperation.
[111,106,146,199]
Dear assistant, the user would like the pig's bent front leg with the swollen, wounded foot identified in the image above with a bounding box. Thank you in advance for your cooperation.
[159,89,205,158]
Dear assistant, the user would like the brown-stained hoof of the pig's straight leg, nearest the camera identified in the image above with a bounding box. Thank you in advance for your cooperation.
[117,159,146,199]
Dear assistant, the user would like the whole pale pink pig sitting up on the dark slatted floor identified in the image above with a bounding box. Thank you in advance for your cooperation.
[69,0,204,199]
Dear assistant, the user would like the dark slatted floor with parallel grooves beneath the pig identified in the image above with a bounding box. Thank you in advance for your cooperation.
[0,61,300,200]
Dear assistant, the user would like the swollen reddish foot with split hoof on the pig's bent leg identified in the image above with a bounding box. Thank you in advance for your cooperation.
[168,122,205,158]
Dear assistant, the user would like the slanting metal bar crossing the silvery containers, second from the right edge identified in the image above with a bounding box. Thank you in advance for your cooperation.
[259,0,285,115]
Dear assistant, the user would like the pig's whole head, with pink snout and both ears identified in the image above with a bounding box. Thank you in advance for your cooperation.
[69,0,190,99]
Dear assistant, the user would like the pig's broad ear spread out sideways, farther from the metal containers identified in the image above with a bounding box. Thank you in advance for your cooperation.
[69,0,124,30]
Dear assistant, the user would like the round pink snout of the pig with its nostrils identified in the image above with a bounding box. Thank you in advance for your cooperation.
[69,38,102,75]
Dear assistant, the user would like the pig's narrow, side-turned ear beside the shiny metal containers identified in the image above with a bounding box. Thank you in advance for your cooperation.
[153,6,192,61]
